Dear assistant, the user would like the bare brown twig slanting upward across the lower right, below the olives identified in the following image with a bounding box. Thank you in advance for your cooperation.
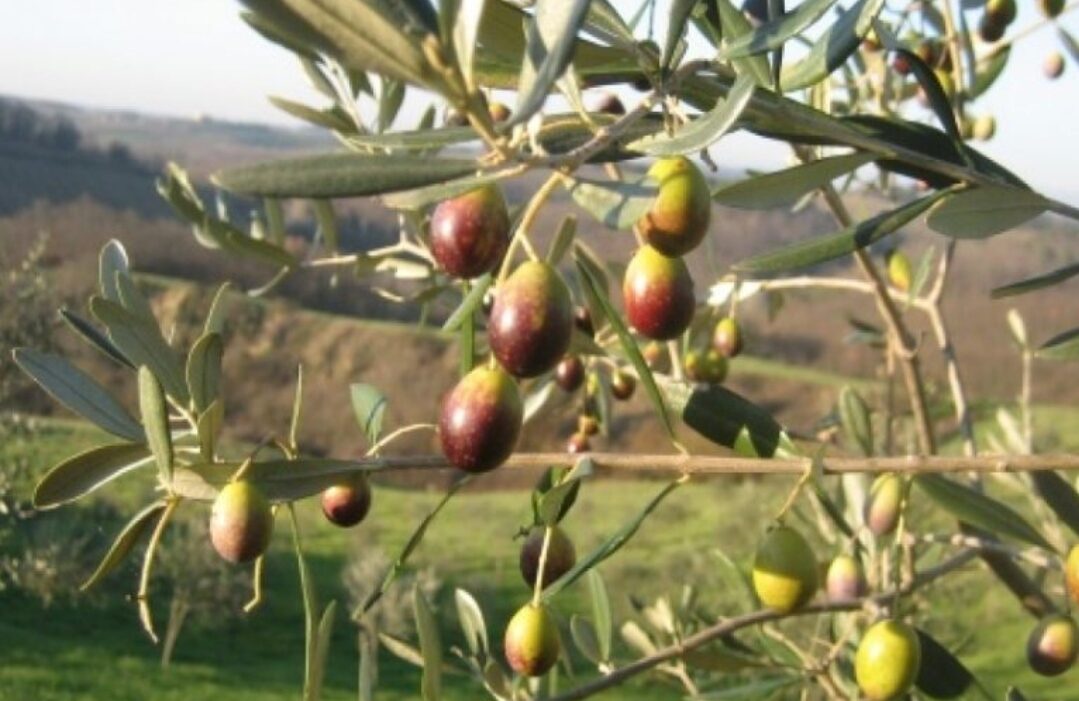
[548,552,975,701]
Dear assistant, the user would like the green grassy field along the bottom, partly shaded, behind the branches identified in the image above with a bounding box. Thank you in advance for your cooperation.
[0,421,1079,701]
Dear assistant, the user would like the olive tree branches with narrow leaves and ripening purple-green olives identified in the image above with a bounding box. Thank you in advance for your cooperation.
[15,0,1079,701]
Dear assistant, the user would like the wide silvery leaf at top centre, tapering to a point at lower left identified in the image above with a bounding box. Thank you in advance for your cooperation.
[509,0,589,125]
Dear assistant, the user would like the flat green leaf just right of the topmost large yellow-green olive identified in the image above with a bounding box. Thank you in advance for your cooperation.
[712,153,877,209]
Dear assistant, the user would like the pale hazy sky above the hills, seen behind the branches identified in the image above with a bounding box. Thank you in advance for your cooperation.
[0,0,1079,199]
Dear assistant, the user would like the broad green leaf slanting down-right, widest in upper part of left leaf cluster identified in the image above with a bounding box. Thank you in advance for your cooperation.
[90,297,189,403]
